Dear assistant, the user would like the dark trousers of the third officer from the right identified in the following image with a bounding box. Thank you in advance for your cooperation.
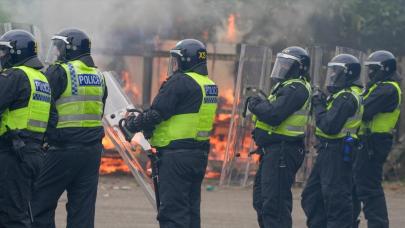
[253,142,305,228]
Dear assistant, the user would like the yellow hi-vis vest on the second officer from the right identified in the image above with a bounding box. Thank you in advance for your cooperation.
[315,86,364,139]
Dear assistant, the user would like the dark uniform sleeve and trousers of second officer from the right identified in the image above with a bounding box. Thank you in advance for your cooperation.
[302,93,358,228]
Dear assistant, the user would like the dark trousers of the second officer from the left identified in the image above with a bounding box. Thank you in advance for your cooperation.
[32,143,102,228]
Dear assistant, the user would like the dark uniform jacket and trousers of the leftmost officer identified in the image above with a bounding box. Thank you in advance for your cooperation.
[0,60,44,228]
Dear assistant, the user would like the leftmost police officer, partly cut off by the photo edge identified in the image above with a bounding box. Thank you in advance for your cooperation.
[0,30,51,228]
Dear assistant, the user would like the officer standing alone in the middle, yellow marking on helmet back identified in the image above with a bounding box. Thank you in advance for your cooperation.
[126,39,218,228]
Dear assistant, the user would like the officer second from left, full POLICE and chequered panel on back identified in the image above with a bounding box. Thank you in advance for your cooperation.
[33,29,107,228]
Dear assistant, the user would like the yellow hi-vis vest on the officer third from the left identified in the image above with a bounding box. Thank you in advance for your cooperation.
[150,73,218,147]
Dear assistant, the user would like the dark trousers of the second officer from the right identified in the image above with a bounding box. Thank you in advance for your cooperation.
[301,142,353,228]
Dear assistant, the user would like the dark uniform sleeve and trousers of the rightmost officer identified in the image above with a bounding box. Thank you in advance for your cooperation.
[353,83,399,228]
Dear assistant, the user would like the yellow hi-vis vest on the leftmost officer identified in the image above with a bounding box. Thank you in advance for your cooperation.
[0,66,51,135]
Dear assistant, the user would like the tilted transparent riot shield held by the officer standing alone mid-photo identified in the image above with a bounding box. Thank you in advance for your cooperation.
[103,72,156,209]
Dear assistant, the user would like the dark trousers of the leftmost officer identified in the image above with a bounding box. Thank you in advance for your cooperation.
[0,145,44,228]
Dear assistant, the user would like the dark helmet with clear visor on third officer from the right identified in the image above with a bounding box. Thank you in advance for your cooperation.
[271,47,311,81]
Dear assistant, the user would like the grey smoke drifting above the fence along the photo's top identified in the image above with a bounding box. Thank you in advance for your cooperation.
[0,0,346,49]
